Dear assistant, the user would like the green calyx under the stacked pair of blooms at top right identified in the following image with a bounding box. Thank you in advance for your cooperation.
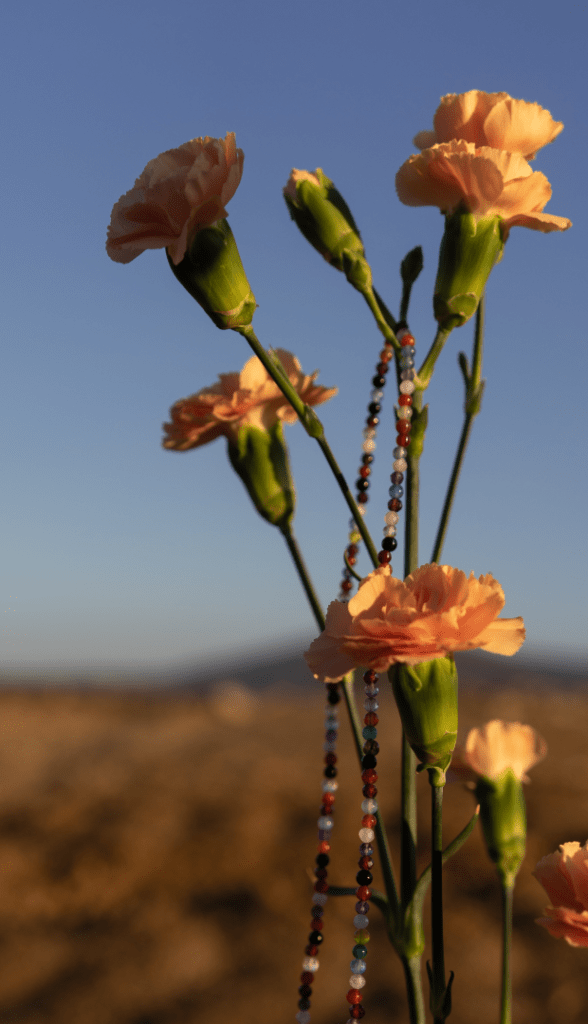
[433,210,504,329]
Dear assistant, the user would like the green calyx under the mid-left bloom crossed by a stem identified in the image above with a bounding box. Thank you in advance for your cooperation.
[228,421,296,527]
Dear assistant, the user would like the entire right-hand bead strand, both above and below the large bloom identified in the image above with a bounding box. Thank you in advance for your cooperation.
[340,328,415,1024]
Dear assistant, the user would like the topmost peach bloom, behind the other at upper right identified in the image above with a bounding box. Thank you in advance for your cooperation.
[414,89,563,160]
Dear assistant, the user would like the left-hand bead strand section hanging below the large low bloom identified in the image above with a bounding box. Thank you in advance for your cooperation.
[296,683,341,1024]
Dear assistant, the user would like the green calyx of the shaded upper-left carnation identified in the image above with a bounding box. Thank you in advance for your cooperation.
[167,219,257,331]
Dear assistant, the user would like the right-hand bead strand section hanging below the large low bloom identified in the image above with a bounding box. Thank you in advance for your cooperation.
[346,669,380,1024]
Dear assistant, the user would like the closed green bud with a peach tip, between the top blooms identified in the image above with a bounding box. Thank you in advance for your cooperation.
[284,167,372,292]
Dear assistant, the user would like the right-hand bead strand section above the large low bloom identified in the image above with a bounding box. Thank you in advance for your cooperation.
[378,328,415,568]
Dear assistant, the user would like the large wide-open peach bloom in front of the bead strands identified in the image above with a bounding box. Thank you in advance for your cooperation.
[304,564,524,683]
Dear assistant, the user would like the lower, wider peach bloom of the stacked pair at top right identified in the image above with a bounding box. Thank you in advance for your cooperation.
[396,140,572,235]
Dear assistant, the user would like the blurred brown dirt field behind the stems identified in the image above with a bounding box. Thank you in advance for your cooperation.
[0,682,588,1024]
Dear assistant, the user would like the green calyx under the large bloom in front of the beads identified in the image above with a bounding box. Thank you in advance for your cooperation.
[388,655,458,785]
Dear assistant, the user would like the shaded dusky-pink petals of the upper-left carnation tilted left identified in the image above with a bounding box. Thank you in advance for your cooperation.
[107,132,244,266]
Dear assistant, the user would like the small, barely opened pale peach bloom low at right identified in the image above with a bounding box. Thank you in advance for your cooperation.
[452,719,547,782]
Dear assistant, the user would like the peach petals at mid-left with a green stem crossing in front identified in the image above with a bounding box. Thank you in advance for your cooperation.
[163,348,338,452]
